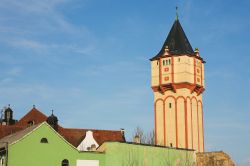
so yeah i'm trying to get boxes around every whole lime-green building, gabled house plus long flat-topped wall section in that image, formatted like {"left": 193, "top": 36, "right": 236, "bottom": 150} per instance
{"left": 0, "top": 122, "right": 195, "bottom": 166}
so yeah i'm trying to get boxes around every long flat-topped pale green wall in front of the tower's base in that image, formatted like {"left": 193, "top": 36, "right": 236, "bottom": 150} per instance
{"left": 103, "top": 142, "right": 195, "bottom": 166}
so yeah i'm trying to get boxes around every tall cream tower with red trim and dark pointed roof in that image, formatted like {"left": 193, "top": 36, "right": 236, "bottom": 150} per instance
{"left": 150, "top": 17, "right": 205, "bottom": 152}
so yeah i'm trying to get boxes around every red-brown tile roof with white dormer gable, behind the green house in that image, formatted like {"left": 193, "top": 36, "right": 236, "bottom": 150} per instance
{"left": 0, "top": 108, "right": 125, "bottom": 147}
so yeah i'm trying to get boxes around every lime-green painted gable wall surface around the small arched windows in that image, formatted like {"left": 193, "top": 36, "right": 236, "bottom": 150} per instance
{"left": 8, "top": 123, "right": 105, "bottom": 166}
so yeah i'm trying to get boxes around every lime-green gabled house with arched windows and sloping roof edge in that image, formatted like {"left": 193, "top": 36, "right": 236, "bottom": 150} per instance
{"left": 0, "top": 122, "right": 105, "bottom": 166}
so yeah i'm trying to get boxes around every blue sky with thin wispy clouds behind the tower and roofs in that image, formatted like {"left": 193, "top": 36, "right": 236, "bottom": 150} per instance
{"left": 0, "top": 0, "right": 250, "bottom": 166}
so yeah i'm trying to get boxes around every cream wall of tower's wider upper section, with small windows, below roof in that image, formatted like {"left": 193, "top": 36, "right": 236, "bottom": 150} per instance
{"left": 151, "top": 55, "right": 205, "bottom": 86}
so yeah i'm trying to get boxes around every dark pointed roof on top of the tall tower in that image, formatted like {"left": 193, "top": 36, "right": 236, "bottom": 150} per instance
{"left": 151, "top": 19, "right": 195, "bottom": 60}
